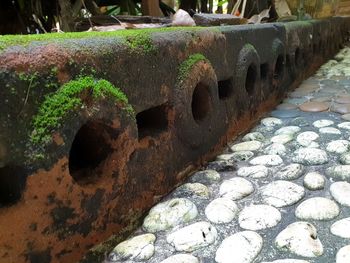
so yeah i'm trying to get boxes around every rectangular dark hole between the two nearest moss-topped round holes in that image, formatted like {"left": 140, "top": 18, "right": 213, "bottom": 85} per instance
{"left": 136, "top": 105, "right": 168, "bottom": 139}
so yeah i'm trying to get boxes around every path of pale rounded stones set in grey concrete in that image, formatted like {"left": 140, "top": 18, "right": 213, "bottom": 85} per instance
{"left": 105, "top": 48, "right": 350, "bottom": 263}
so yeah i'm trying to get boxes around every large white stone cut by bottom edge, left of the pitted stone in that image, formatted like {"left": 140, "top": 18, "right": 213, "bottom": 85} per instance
{"left": 215, "top": 231, "right": 263, "bottom": 263}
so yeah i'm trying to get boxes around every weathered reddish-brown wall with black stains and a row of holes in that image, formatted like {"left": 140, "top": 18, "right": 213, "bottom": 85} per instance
{"left": 0, "top": 18, "right": 350, "bottom": 263}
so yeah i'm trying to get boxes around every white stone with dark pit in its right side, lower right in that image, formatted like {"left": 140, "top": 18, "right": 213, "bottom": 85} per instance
{"left": 275, "top": 222, "right": 323, "bottom": 258}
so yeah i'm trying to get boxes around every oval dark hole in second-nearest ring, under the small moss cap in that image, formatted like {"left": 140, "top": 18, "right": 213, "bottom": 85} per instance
{"left": 192, "top": 82, "right": 211, "bottom": 122}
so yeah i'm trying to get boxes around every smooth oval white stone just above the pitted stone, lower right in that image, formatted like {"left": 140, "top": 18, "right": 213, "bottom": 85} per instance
{"left": 295, "top": 197, "right": 340, "bottom": 220}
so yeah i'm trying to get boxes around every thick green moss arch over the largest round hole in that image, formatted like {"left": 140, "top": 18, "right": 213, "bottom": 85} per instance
{"left": 30, "top": 76, "right": 134, "bottom": 144}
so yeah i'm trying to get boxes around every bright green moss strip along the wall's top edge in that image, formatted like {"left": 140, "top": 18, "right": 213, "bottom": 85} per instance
{"left": 0, "top": 27, "right": 207, "bottom": 52}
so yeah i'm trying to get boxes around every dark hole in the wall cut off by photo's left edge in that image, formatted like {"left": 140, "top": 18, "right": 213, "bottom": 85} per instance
{"left": 0, "top": 165, "right": 26, "bottom": 206}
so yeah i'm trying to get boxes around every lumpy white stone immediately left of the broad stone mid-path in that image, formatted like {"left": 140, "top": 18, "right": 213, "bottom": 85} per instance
{"left": 220, "top": 177, "right": 254, "bottom": 200}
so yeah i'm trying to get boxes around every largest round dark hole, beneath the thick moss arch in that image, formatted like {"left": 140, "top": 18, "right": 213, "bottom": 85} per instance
{"left": 69, "top": 121, "right": 112, "bottom": 183}
